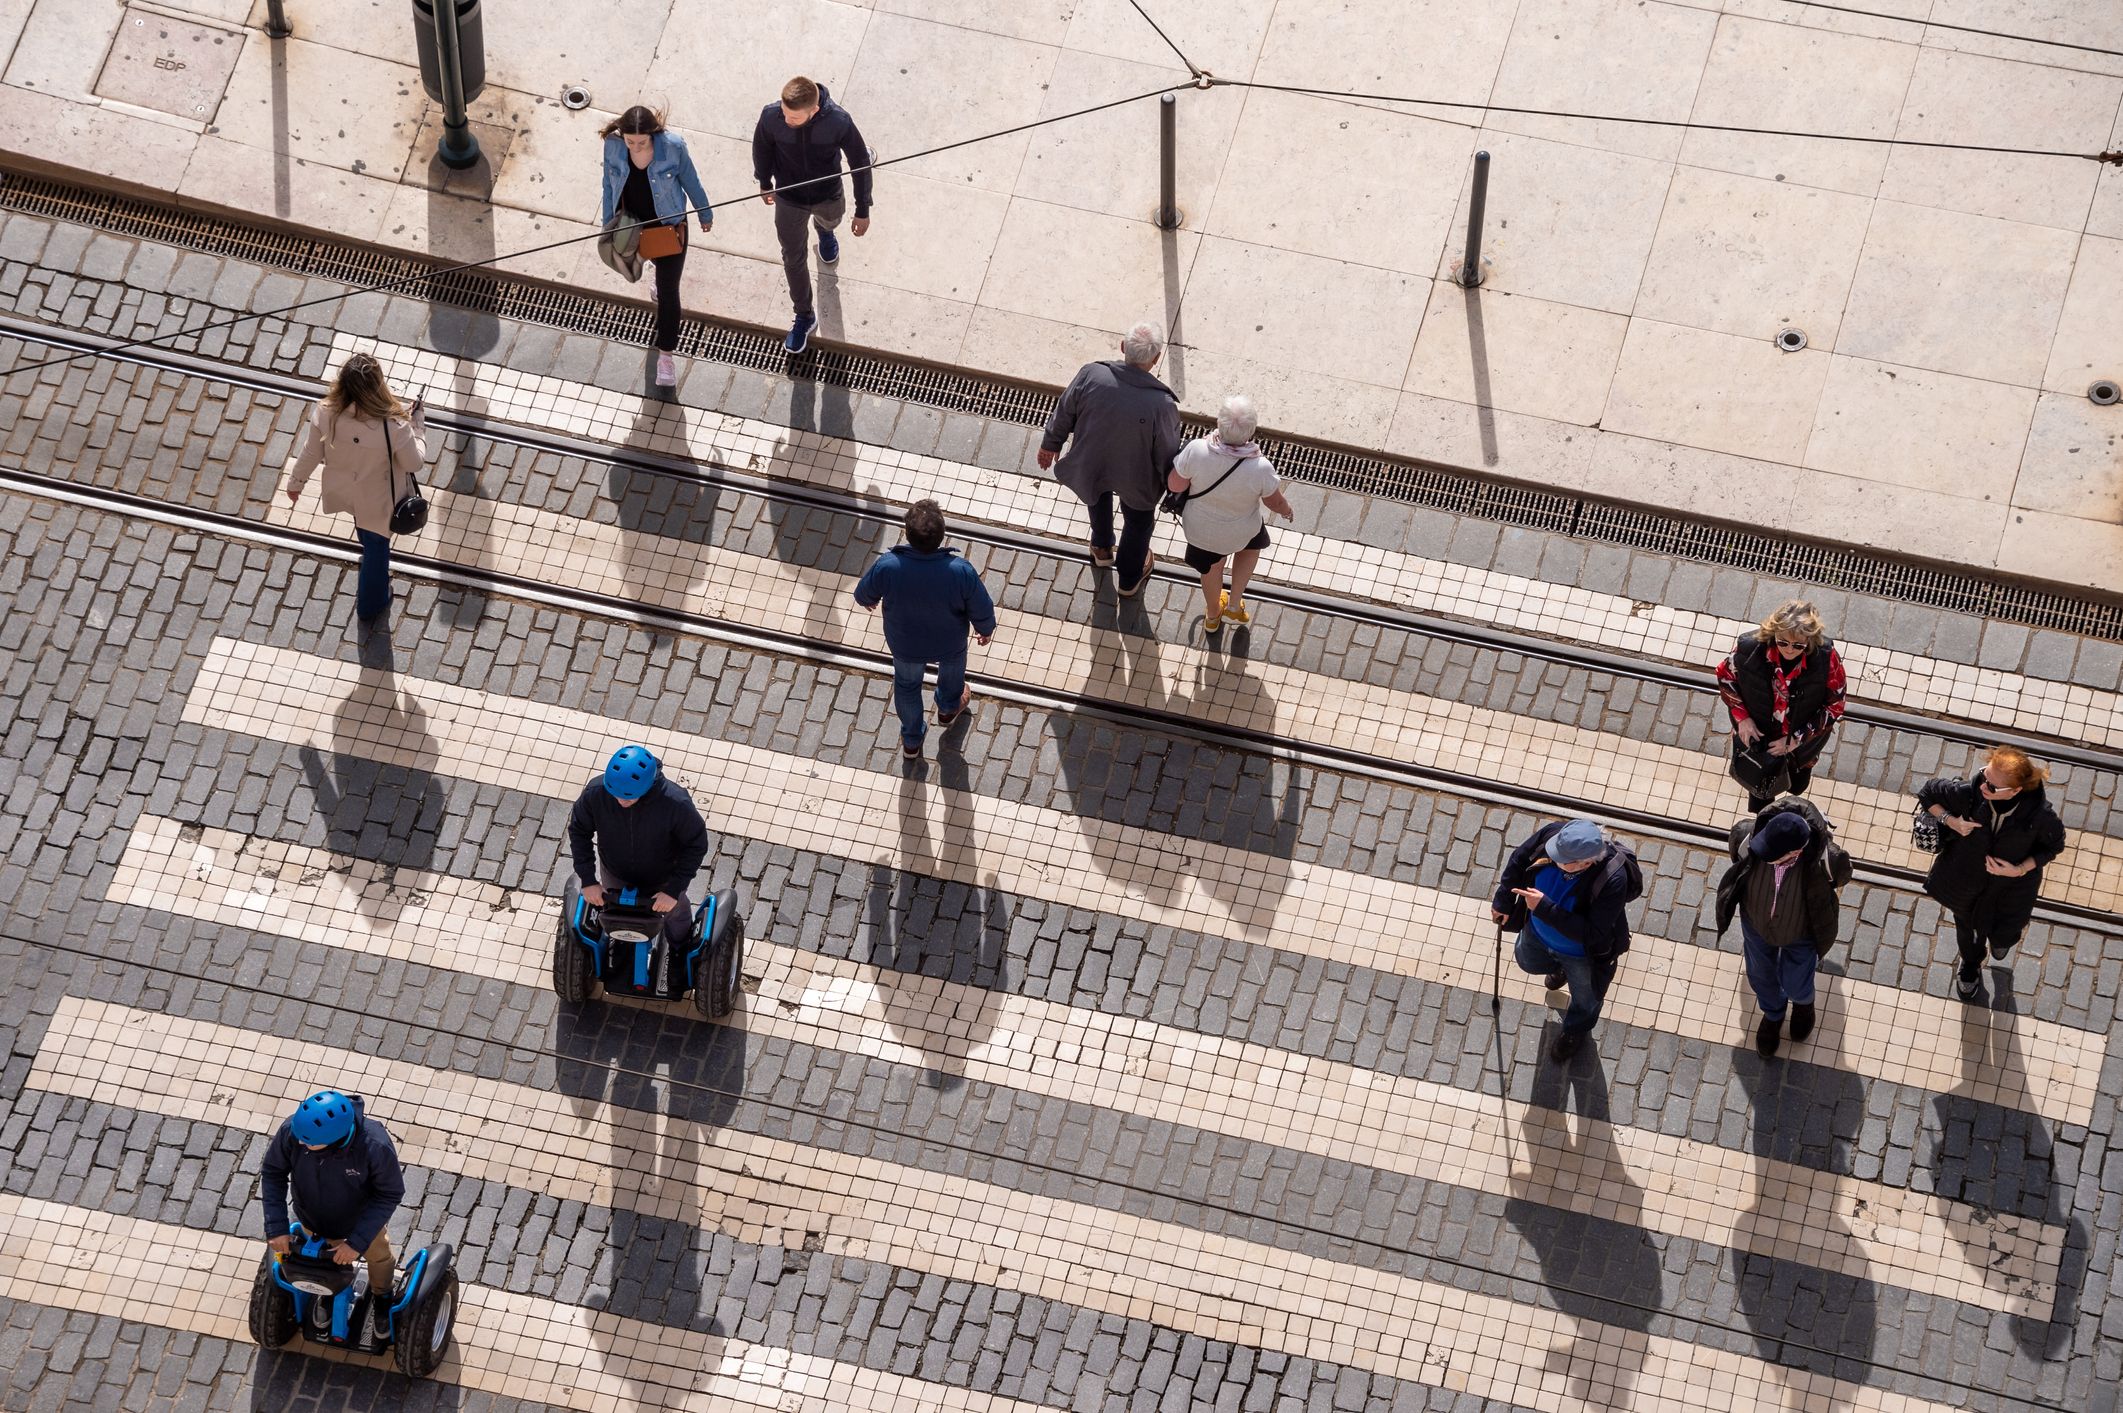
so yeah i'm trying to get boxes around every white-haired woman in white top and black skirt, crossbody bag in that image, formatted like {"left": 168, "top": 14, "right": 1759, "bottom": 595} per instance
{"left": 1166, "top": 397, "right": 1291, "bottom": 632}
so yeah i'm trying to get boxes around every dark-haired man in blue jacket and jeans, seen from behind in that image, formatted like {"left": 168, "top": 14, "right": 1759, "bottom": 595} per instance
{"left": 856, "top": 501, "right": 996, "bottom": 760}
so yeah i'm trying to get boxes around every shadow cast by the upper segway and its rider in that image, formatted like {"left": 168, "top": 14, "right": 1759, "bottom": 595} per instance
{"left": 552, "top": 988, "right": 749, "bottom": 1407}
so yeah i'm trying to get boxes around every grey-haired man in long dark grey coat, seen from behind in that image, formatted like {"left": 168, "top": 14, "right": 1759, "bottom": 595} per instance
{"left": 1040, "top": 322, "right": 1180, "bottom": 598}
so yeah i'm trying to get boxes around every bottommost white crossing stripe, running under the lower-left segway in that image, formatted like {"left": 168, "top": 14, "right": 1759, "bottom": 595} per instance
{"left": 0, "top": 1192, "right": 1053, "bottom": 1413}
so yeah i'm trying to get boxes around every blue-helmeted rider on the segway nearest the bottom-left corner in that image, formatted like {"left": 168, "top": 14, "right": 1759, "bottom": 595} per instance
{"left": 259, "top": 1088, "right": 405, "bottom": 1339}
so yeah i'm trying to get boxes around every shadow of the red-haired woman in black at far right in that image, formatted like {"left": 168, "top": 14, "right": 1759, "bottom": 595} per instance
{"left": 1926, "top": 965, "right": 2089, "bottom": 1360}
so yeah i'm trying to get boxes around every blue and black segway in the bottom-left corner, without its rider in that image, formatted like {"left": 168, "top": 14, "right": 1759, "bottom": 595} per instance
{"left": 251, "top": 1222, "right": 456, "bottom": 1379}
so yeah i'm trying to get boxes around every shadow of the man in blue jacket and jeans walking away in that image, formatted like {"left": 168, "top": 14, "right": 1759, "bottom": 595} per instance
{"left": 866, "top": 715, "right": 1013, "bottom": 1091}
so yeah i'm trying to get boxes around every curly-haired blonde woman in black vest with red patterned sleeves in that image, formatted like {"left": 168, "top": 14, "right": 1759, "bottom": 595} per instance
{"left": 1718, "top": 598, "right": 1843, "bottom": 815}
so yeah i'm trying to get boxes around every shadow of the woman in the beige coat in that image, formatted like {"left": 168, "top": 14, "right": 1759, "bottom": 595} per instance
{"left": 297, "top": 661, "right": 450, "bottom": 927}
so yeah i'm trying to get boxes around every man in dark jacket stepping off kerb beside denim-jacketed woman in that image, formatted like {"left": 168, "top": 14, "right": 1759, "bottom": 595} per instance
{"left": 752, "top": 74, "right": 870, "bottom": 354}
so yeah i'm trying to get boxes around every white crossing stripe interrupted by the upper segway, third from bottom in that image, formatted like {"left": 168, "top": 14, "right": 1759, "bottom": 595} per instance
{"left": 103, "top": 817, "right": 2064, "bottom": 1318}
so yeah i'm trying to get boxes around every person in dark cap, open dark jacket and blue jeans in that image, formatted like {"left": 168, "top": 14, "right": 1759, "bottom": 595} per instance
{"left": 1718, "top": 798, "right": 1851, "bottom": 1059}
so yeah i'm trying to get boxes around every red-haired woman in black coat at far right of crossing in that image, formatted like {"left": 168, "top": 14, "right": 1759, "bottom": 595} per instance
{"left": 1917, "top": 747, "right": 2064, "bottom": 1001}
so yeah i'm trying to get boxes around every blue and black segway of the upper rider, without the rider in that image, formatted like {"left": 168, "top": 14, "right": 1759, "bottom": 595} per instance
{"left": 552, "top": 878, "right": 745, "bottom": 1021}
